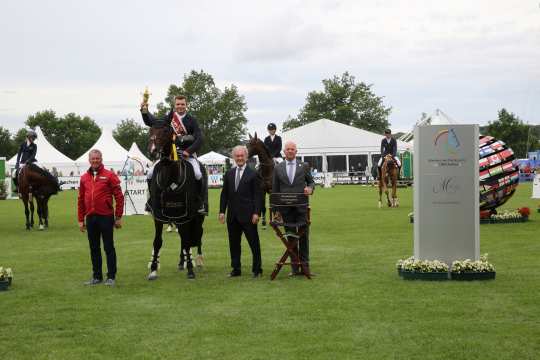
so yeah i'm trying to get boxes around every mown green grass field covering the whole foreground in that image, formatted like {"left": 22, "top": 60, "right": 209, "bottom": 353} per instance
{"left": 0, "top": 184, "right": 540, "bottom": 359}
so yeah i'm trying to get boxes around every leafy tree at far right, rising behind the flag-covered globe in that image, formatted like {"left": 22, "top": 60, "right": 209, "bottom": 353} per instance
{"left": 486, "top": 108, "right": 538, "bottom": 158}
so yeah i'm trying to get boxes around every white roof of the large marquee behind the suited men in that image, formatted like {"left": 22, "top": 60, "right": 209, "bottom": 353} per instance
{"left": 282, "top": 119, "right": 410, "bottom": 155}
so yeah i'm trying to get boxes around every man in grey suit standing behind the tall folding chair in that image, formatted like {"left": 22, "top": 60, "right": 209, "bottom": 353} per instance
{"left": 272, "top": 141, "right": 315, "bottom": 275}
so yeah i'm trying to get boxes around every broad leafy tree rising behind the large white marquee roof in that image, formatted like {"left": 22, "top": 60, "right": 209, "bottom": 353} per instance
{"left": 283, "top": 72, "right": 392, "bottom": 133}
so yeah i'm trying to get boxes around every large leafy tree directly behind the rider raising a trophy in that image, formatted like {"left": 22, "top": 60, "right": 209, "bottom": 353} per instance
{"left": 156, "top": 70, "right": 247, "bottom": 154}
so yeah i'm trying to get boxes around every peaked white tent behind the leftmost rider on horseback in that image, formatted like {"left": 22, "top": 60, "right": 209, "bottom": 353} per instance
{"left": 8, "top": 126, "right": 77, "bottom": 176}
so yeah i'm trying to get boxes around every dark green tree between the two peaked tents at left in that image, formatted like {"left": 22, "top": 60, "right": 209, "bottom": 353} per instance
{"left": 25, "top": 110, "right": 101, "bottom": 159}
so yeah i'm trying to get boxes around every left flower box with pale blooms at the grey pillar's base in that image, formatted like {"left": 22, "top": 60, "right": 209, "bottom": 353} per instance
{"left": 396, "top": 257, "right": 448, "bottom": 280}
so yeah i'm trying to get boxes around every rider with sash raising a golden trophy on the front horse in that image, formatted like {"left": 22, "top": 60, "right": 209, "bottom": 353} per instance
{"left": 141, "top": 95, "right": 208, "bottom": 214}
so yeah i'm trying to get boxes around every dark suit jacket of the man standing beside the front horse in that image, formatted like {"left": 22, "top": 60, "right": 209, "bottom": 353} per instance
{"left": 219, "top": 166, "right": 262, "bottom": 223}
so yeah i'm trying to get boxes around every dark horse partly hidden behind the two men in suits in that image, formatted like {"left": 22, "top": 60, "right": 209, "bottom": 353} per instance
{"left": 246, "top": 133, "right": 274, "bottom": 228}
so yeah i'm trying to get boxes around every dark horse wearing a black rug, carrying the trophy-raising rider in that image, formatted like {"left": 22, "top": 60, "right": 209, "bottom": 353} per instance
{"left": 148, "top": 122, "right": 204, "bottom": 280}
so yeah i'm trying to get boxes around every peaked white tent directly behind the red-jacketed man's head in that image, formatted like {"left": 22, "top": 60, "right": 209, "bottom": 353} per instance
{"left": 75, "top": 128, "right": 128, "bottom": 173}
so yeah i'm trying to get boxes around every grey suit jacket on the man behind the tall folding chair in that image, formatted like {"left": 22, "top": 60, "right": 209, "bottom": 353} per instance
{"left": 272, "top": 159, "right": 315, "bottom": 197}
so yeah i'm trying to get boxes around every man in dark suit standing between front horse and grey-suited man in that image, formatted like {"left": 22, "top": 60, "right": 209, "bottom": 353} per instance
{"left": 219, "top": 146, "right": 262, "bottom": 278}
